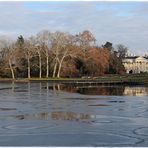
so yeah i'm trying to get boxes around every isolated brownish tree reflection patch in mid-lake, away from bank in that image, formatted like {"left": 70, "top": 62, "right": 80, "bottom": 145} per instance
{"left": 51, "top": 111, "right": 91, "bottom": 121}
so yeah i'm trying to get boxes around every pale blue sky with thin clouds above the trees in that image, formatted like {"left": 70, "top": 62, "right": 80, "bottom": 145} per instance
{"left": 0, "top": 1, "right": 148, "bottom": 55}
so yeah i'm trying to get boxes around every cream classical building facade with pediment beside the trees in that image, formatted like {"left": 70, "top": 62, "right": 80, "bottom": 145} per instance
{"left": 122, "top": 56, "right": 148, "bottom": 73}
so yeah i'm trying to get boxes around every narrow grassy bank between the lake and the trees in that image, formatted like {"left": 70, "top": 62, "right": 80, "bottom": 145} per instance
{"left": 0, "top": 74, "right": 148, "bottom": 84}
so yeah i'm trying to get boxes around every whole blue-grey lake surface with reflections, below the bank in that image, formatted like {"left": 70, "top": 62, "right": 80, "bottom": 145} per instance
{"left": 0, "top": 83, "right": 148, "bottom": 146}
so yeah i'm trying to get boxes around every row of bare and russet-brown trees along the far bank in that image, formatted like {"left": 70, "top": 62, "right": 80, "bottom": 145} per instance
{"left": 0, "top": 30, "right": 128, "bottom": 79}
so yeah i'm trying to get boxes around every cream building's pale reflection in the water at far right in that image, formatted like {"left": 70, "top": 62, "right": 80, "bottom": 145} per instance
{"left": 124, "top": 87, "right": 148, "bottom": 96}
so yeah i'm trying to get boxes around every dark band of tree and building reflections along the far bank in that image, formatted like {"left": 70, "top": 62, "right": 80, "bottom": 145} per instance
{"left": 42, "top": 84, "right": 148, "bottom": 96}
